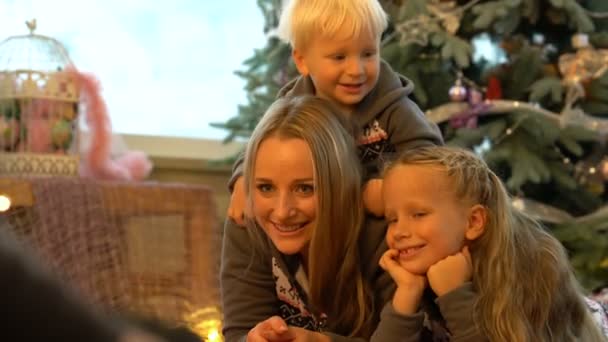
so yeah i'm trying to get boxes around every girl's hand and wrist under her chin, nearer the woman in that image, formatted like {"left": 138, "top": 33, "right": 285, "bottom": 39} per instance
{"left": 380, "top": 249, "right": 427, "bottom": 315}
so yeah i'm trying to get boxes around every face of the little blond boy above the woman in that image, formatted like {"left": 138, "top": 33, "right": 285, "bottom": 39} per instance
{"left": 293, "top": 26, "right": 380, "bottom": 113}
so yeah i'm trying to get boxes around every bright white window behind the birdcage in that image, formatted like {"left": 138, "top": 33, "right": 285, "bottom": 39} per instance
{"left": 0, "top": 0, "right": 266, "bottom": 139}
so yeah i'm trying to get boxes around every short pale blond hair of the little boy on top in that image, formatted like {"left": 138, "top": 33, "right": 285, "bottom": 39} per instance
{"left": 278, "top": 0, "right": 388, "bottom": 49}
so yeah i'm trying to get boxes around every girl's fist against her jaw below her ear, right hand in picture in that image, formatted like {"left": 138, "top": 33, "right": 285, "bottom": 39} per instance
{"left": 426, "top": 246, "right": 473, "bottom": 296}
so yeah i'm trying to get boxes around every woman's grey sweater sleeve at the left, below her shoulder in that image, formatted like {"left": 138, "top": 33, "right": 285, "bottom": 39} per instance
{"left": 220, "top": 220, "right": 277, "bottom": 342}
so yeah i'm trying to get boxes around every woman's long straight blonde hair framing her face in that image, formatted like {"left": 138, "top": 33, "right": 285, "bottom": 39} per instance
{"left": 244, "top": 96, "right": 371, "bottom": 335}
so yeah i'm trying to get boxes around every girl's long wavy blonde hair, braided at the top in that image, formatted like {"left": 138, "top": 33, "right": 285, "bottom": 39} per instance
{"left": 385, "top": 146, "right": 605, "bottom": 342}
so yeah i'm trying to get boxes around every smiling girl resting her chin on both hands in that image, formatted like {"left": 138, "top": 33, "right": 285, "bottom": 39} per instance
{"left": 377, "top": 147, "right": 608, "bottom": 341}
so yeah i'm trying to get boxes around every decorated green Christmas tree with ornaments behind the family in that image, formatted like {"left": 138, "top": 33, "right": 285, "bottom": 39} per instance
{"left": 214, "top": 0, "right": 608, "bottom": 289}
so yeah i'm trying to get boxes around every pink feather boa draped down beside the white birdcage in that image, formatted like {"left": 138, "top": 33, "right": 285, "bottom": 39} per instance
{"left": 66, "top": 68, "right": 152, "bottom": 181}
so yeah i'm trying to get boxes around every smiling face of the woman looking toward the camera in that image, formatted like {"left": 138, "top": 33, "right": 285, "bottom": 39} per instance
{"left": 253, "top": 136, "right": 317, "bottom": 255}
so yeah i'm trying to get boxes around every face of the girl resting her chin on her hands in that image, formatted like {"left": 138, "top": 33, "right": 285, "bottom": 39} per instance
{"left": 383, "top": 165, "right": 480, "bottom": 275}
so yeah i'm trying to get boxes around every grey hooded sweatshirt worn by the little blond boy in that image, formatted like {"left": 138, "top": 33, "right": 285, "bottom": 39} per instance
{"left": 228, "top": 61, "right": 443, "bottom": 191}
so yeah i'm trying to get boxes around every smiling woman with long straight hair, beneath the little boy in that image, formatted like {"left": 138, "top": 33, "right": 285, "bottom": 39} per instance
{"left": 221, "top": 96, "right": 394, "bottom": 342}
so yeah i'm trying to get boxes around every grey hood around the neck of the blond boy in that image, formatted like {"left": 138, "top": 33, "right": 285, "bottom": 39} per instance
{"left": 277, "top": 60, "right": 414, "bottom": 127}
